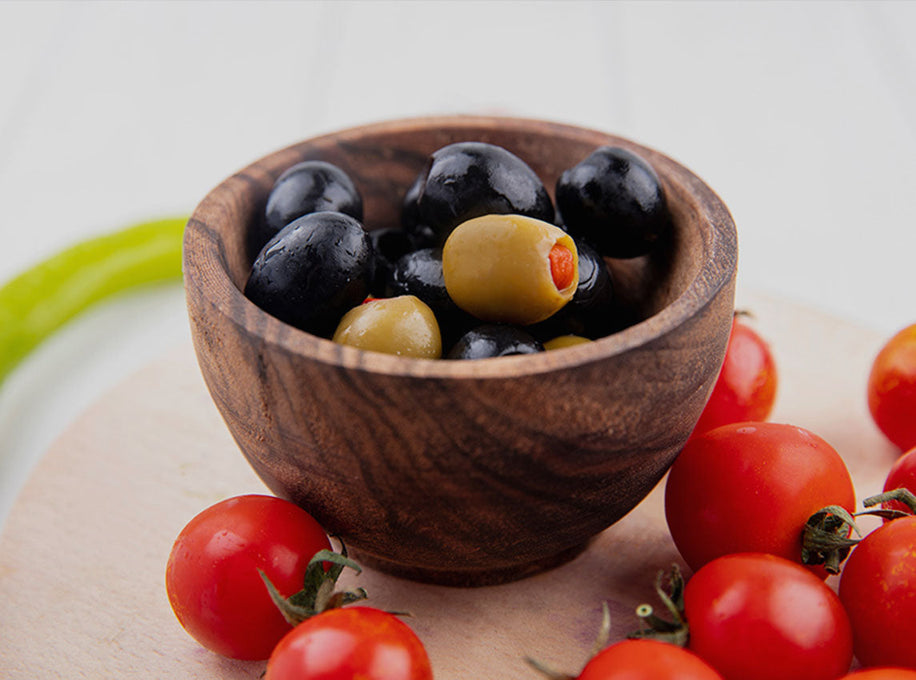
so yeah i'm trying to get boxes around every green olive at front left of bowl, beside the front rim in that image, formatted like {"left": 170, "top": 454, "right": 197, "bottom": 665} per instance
{"left": 332, "top": 295, "right": 442, "bottom": 359}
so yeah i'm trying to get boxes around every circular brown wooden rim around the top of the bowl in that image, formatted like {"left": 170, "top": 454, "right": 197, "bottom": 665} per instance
{"left": 182, "top": 115, "right": 738, "bottom": 380}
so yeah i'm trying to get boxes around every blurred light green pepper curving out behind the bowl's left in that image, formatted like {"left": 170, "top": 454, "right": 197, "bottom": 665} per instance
{"left": 0, "top": 218, "right": 187, "bottom": 383}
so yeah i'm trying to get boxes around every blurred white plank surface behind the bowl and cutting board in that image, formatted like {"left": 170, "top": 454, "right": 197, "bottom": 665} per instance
{"left": 0, "top": 1, "right": 916, "bottom": 521}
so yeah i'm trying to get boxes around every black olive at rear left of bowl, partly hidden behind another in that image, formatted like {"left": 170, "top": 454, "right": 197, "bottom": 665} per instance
{"left": 250, "top": 161, "right": 363, "bottom": 252}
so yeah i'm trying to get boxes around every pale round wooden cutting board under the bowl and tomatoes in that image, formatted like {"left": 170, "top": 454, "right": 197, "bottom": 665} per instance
{"left": 0, "top": 295, "right": 898, "bottom": 680}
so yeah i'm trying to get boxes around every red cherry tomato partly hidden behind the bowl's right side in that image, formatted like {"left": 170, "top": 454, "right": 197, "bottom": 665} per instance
{"left": 693, "top": 318, "right": 777, "bottom": 435}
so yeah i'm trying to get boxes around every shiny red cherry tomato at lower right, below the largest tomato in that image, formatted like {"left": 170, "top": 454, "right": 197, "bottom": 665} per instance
{"left": 684, "top": 553, "right": 852, "bottom": 680}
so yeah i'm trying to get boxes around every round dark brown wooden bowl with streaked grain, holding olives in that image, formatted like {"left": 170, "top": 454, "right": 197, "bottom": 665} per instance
{"left": 184, "top": 117, "right": 737, "bottom": 585}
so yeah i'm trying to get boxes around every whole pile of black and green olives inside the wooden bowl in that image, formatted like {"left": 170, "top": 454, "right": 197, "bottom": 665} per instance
{"left": 245, "top": 142, "right": 671, "bottom": 359}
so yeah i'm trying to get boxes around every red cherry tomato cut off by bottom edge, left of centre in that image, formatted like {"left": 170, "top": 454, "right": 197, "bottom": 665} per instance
{"left": 264, "top": 607, "right": 433, "bottom": 680}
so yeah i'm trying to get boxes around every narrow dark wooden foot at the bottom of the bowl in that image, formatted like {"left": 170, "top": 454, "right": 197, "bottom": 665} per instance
{"left": 348, "top": 541, "right": 591, "bottom": 588}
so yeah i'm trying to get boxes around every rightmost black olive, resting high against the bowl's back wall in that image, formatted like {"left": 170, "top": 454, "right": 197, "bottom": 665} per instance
{"left": 556, "top": 146, "right": 671, "bottom": 258}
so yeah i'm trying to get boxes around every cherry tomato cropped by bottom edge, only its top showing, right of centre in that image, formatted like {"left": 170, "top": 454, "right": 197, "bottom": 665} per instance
{"left": 577, "top": 640, "right": 722, "bottom": 680}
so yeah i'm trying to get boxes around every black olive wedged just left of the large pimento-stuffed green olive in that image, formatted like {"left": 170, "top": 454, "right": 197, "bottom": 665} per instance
{"left": 386, "top": 248, "right": 480, "bottom": 343}
